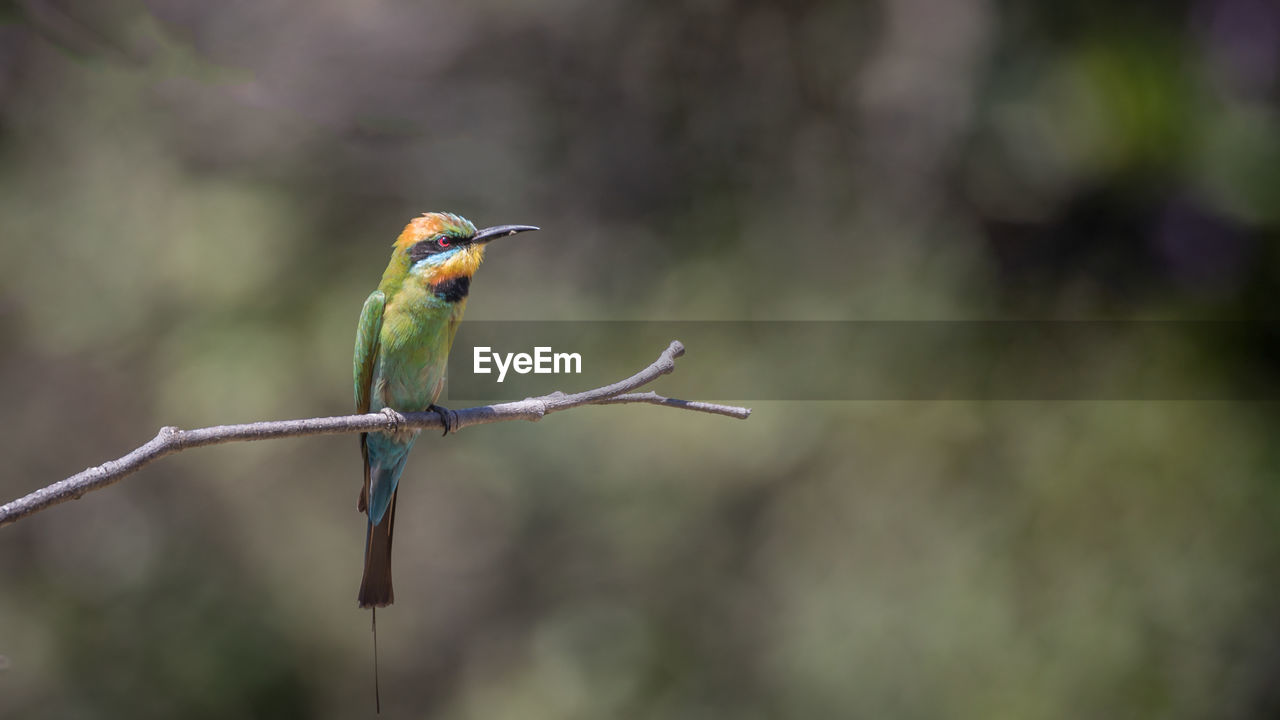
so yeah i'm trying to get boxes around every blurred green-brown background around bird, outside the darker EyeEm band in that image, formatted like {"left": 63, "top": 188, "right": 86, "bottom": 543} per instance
{"left": 0, "top": 0, "right": 1280, "bottom": 720}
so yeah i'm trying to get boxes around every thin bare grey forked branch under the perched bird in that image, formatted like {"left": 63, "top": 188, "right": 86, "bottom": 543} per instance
{"left": 0, "top": 341, "right": 751, "bottom": 527}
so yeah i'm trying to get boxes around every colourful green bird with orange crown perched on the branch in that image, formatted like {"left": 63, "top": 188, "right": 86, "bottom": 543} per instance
{"left": 355, "top": 213, "right": 538, "bottom": 607}
